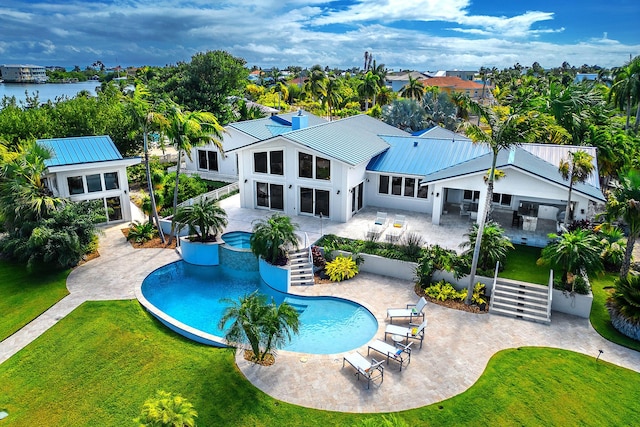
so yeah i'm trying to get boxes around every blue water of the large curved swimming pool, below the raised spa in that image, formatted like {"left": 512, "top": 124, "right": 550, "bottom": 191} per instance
{"left": 141, "top": 261, "right": 378, "bottom": 354}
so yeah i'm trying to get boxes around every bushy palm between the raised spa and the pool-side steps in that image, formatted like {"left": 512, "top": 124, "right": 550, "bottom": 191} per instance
{"left": 250, "top": 213, "right": 298, "bottom": 265}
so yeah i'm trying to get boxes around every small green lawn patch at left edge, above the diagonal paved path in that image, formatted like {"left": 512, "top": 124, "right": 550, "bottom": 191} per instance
{"left": 0, "top": 260, "right": 70, "bottom": 341}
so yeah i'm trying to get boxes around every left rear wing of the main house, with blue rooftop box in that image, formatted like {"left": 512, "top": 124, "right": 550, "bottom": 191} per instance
{"left": 183, "top": 111, "right": 326, "bottom": 182}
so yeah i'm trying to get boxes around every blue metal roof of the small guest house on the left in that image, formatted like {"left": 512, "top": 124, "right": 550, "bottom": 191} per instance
{"left": 37, "top": 135, "right": 123, "bottom": 167}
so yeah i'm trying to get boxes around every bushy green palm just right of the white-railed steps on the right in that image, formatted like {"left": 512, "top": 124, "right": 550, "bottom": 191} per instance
{"left": 538, "top": 228, "right": 604, "bottom": 291}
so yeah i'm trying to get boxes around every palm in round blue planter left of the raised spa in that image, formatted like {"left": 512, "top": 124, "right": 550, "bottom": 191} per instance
{"left": 175, "top": 198, "right": 227, "bottom": 265}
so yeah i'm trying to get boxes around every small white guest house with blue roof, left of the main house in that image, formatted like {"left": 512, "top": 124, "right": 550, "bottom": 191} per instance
{"left": 37, "top": 135, "right": 141, "bottom": 223}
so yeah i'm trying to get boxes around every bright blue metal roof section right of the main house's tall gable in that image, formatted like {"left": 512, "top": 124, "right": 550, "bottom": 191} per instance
{"left": 367, "top": 136, "right": 489, "bottom": 176}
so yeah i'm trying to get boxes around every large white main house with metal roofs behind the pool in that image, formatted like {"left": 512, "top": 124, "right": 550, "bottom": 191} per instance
{"left": 186, "top": 115, "right": 605, "bottom": 241}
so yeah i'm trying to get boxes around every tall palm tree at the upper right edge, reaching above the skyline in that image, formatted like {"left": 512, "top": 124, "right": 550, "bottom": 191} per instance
{"left": 609, "top": 56, "right": 640, "bottom": 130}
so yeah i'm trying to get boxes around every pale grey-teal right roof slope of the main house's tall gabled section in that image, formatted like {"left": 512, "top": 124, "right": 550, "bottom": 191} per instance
{"left": 283, "top": 114, "right": 410, "bottom": 165}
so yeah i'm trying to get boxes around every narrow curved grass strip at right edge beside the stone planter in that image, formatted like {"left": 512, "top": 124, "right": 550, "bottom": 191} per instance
{"left": 589, "top": 273, "right": 640, "bottom": 351}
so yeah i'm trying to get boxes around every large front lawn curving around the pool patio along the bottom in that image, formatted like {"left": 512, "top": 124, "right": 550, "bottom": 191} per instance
{"left": 0, "top": 301, "right": 640, "bottom": 426}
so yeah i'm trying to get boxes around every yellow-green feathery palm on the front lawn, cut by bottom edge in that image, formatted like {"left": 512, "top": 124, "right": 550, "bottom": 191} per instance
{"left": 134, "top": 390, "right": 198, "bottom": 427}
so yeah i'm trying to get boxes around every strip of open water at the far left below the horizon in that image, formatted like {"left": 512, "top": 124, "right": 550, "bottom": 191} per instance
{"left": 0, "top": 80, "right": 100, "bottom": 104}
